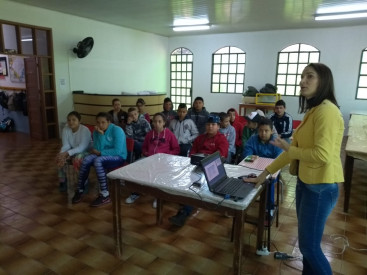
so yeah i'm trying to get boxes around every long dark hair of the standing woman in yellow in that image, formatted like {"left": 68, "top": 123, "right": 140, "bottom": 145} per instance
{"left": 299, "top": 63, "right": 339, "bottom": 113}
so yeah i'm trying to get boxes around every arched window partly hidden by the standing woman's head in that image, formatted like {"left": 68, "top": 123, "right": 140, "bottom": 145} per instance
{"left": 275, "top": 43, "right": 320, "bottom": 96}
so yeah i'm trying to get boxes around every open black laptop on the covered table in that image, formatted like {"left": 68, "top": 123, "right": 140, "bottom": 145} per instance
{"left": 201, "top": 151, "right": 255, "bottom": 199}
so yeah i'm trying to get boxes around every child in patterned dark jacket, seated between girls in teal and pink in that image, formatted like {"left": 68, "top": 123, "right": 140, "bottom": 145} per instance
{"left": 126, "top": 107, "right": 152, "bottom": 160}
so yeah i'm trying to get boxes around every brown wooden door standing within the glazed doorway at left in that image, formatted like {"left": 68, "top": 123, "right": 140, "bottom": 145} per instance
{"left": 24, "top": 57, "right": 46, "bottom": 140}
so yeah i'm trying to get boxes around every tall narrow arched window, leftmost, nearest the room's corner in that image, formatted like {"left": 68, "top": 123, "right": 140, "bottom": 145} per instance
{"left": 170, "top": 48, "right": 193, "bottom": 110}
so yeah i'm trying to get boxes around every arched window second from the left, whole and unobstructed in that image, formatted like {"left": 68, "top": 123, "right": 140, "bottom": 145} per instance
{"left": 211, "top": 46, "right": 246, "bottom": 94}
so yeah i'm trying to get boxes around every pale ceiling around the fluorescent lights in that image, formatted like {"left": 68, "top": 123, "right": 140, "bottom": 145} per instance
{"left": 11, "top": 0, "right": 367, "bottom": 37}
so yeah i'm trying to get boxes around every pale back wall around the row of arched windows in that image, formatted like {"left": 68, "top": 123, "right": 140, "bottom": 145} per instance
{"left": 169, "top": 26, "right": 367, "bottom": 126}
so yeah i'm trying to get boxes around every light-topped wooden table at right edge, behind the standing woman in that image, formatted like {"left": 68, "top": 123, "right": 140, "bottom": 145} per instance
{"left": 344, "top": 114, "right": 367, "bottom": 212}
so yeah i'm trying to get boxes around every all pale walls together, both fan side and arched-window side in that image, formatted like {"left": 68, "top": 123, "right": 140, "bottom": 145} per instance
{"left": 0, "top": 0, "right": 367, "bottom": 133}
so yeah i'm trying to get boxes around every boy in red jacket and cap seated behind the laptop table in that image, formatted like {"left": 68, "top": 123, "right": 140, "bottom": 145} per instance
{"left": 169, "top": 115, "right": 229, "bottom": 226}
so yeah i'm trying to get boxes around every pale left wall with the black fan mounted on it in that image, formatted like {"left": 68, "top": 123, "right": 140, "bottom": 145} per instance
{"left": 0, "top": 0, "right": 169, "bottom": 127}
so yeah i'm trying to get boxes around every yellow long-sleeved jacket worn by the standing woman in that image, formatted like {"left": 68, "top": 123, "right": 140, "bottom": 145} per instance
{"left": 266, "top": 100, "right": 344, "bottom": 184}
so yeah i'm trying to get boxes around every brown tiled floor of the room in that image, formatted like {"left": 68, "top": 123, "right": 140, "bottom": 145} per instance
{"left": 0, "top": 133, "right": 367, "bottom": 275}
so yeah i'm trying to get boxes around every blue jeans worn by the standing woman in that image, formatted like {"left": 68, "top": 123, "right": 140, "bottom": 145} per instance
{"left": 296, "top": 179, "right": 339, "bottom": 275}
